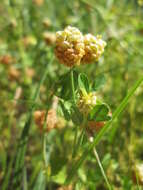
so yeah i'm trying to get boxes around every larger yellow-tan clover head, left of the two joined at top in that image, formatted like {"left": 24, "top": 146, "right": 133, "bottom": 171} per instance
{"left": 55, "top": 26, "right": 85, "bottom": 67}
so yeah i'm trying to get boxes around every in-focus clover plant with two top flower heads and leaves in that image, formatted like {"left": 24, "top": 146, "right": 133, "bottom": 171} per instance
{"left": 55, "top": 26, "right": 110, "bottom": 135}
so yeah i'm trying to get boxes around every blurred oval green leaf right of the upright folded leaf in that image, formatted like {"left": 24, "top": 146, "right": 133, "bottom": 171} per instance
{"left": 92, "top": 74, "right": 106, "bottom": 91}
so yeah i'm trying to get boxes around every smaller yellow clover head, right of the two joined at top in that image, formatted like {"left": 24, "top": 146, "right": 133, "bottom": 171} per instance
{"left": 82, "top": 34, "right": 106, "bottom": 64}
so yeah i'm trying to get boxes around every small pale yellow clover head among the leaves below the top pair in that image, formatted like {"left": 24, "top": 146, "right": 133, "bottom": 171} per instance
{"left": 77, "top": 92, "right": 97, "bottom": 115}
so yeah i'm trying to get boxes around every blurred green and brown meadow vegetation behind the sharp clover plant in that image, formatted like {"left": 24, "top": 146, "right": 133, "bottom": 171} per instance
{"left": 0, "top": 0, "right": 143, "bottom": 190}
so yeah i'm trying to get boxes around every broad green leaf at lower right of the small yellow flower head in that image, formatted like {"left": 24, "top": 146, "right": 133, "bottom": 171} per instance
{"left": 89, "top": 103, "right": 111, "bottom": 121}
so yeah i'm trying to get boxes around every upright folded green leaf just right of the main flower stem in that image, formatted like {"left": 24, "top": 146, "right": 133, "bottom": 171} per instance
{"left": 78, "top": 73, "right": 89, "bottom": 92}
